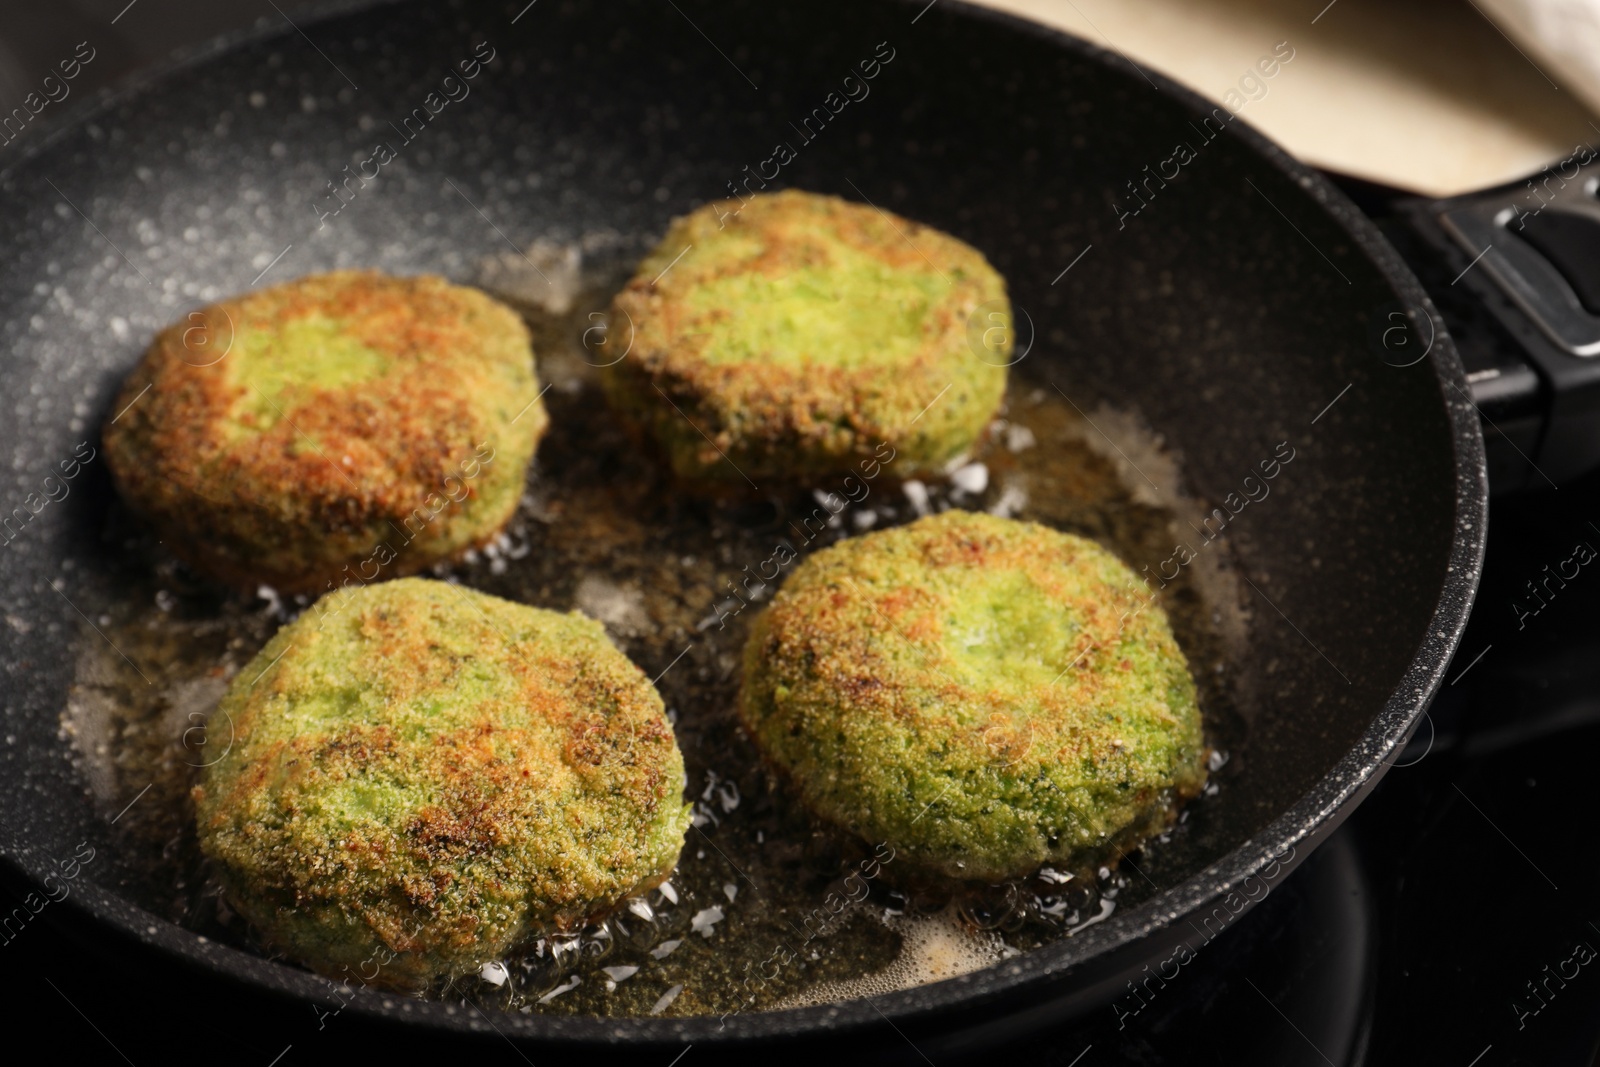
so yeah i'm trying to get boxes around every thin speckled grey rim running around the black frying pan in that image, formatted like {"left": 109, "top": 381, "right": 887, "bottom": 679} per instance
{"left": 0, "top": 0, "right": 1488, "bottom": 1048}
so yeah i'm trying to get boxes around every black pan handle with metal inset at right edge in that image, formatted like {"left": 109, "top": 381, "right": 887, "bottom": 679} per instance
{"left": 1379, "top": 159, "right": 1600, "bottom": 496}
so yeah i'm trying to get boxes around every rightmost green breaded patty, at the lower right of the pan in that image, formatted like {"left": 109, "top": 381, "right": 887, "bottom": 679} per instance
{"left": 739, "top": 510, "right": 1206, "bottom": 880}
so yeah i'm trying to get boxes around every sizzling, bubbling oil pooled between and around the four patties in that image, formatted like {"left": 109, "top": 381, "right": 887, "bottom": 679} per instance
{"left": 62, "top": 247, "right": 1242, "bottom": 1016}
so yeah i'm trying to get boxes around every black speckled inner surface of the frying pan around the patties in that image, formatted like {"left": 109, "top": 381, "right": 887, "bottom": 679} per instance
{"left": 0, "top": 3, "right": 1456, "bottom": 1036}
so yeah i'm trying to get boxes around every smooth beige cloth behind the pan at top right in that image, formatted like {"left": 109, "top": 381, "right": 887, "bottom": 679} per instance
{"left": 978, "top": 0, "right": 1600, "bottom": 195}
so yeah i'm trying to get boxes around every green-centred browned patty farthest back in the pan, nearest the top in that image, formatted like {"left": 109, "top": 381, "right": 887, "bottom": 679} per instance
{"left": 605, "top": 190, "right": 1010, "bottom": 482}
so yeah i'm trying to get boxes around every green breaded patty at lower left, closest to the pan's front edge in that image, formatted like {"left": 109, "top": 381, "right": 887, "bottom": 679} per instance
{"left": 194, "top": 579, "right": 690, "bottom": 987}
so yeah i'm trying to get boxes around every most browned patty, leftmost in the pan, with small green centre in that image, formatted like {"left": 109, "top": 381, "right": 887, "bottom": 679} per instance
{"left": 104, "top": 272, "right": 547, "bottom": 590}
